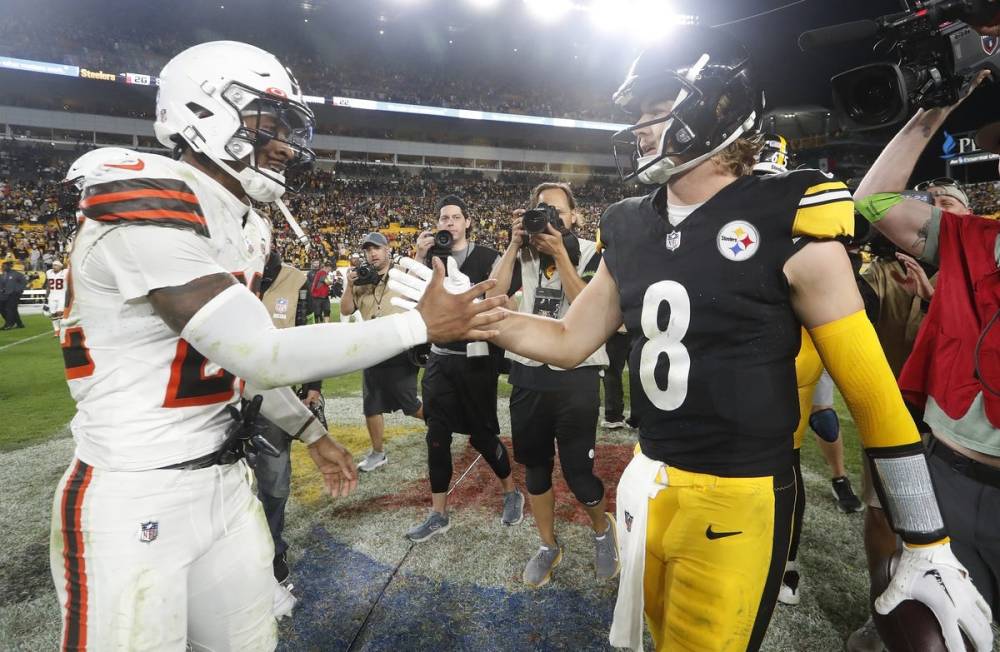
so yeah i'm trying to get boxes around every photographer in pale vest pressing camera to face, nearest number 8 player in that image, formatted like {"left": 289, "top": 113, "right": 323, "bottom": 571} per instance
{"left": 488, "top": 183, "right": 618, "bottom": 588}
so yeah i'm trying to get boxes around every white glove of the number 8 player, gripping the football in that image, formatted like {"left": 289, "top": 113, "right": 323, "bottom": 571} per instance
{"left": 875, "top": 543, "right": 993, "bottom": 652}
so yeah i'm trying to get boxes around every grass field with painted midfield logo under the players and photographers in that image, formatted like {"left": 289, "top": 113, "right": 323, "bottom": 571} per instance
{"left": 0, "top": 306, "right": 908, "bottom": 651}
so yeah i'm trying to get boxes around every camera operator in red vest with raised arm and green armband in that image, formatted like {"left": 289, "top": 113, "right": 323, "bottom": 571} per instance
{"left": 855, "top": 74, "right": 1000, "bottom": 632}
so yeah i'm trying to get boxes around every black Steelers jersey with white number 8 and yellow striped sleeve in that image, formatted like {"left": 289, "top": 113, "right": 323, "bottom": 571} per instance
{"left": 600, "top": 170, "right": 854, "bottom": 476}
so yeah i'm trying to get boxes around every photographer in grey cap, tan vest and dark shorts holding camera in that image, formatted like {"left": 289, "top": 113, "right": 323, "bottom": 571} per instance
{"left": 340, "top": 231, "right": 424, "bottom": 471}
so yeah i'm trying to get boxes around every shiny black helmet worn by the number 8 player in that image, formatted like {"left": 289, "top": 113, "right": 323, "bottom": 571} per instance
{"left": 612, "top": 26, "right": 764, "bottom": 185}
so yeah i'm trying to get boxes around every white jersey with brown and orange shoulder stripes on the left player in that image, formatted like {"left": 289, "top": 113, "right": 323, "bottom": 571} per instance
{"left": 62, "top": 153, "right": 271, "bottom": 471}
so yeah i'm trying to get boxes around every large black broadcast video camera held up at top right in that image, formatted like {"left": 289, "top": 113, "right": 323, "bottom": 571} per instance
{"left": 799, "top": 0, "right": 1000, "bottom": 130}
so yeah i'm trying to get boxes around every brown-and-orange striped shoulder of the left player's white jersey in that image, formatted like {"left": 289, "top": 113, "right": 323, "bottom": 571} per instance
{"left": 79, "top": 152, "right": 209, "bottom": 237}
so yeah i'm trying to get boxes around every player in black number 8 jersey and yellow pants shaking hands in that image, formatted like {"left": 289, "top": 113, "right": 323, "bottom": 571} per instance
{"left": 486, "top": 27, "right": 992, "bottom": 651}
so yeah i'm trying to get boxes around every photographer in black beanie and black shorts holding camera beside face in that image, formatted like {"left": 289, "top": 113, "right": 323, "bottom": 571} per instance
{"left": 406, "top": 195, "right": 524, "bottom": 541}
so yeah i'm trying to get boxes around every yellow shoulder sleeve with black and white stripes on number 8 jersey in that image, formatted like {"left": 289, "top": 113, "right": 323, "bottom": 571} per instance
{"left": 781, "top": 169, "right": 854, "bottom": 238}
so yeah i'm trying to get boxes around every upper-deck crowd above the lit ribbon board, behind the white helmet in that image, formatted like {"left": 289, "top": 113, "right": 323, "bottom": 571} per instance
{"left": 0, "top": 7, "right": 614, "bottom": 120}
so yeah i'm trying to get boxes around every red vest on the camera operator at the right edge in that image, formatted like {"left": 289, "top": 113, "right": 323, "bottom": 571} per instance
{"left": 899, "top": 213, "right": 1000, "bottom": 428}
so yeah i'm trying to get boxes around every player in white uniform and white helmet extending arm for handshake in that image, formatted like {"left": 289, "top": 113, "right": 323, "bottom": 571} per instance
{"left": 51, "top": 41, "right": 503, "bottom": 650}
